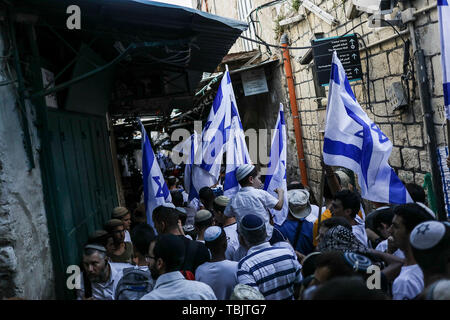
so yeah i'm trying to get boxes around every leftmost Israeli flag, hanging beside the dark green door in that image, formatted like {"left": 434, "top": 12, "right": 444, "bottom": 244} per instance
{"left": 139, "top": 121, "right": 172, "bottom": 228}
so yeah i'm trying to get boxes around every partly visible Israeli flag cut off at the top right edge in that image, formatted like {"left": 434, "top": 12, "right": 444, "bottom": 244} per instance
{"left": 437, "top": 0, "right": 450, "bottom": 120}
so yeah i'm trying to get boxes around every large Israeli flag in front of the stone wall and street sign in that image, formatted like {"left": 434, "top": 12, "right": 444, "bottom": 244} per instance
{"left": 323, "top": 51, "right": 413, "bottom": 204}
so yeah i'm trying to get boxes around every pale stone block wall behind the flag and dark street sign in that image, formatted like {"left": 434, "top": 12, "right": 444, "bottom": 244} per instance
{"left": 210, "top": 0, "right": 447, "bottom": 200}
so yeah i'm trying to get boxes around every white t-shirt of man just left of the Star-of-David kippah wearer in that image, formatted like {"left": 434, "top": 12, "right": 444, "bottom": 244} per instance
{"left": 392, "top": 264, "right": 424, "bottom": 300}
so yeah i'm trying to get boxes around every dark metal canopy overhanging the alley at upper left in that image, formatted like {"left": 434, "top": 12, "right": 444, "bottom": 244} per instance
{"left": 14, "top": 0, "right": 248, "bottom": 114}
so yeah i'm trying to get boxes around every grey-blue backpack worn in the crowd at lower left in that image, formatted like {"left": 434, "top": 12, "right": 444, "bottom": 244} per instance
{"left": 114, "top": 267, "right": 153, "bottom": 300}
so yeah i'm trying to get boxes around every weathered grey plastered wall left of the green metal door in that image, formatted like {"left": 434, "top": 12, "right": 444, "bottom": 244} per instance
{"left": 0, "top": 28, "right": 54, "bottom": 299}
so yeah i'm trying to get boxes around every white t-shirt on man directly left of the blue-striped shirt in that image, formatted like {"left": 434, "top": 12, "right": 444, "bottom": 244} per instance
{"left": 195, "top": 260, "right": 238, "bottom": 300}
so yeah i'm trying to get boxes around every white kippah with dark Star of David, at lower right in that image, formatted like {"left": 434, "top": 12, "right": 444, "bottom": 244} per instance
{"left": 409, "top": 221, "right": 445, "bottom": 250}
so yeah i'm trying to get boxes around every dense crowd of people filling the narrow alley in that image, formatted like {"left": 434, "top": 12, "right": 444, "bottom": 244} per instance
{"left": 77, "top": 164, "right": 450, "bottom": 300}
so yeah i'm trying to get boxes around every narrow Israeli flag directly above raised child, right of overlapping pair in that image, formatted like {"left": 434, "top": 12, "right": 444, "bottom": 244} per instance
{"left": 223, "top": 97, "right": 251, "bottom": 198}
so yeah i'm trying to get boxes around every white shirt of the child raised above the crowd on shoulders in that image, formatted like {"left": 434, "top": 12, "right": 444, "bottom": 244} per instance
{"left": 224, "top": 187, "right": 278, "bottom": 240}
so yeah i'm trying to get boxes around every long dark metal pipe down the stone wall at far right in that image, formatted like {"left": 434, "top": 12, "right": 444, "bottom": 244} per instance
{"left": 408, "top": 4, "right": 447, "bottom": 221}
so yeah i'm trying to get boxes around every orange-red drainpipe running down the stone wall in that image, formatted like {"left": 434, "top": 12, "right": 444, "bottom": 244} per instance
{"left": 281, "top": 34, "right": 308, "bottom": 186}
